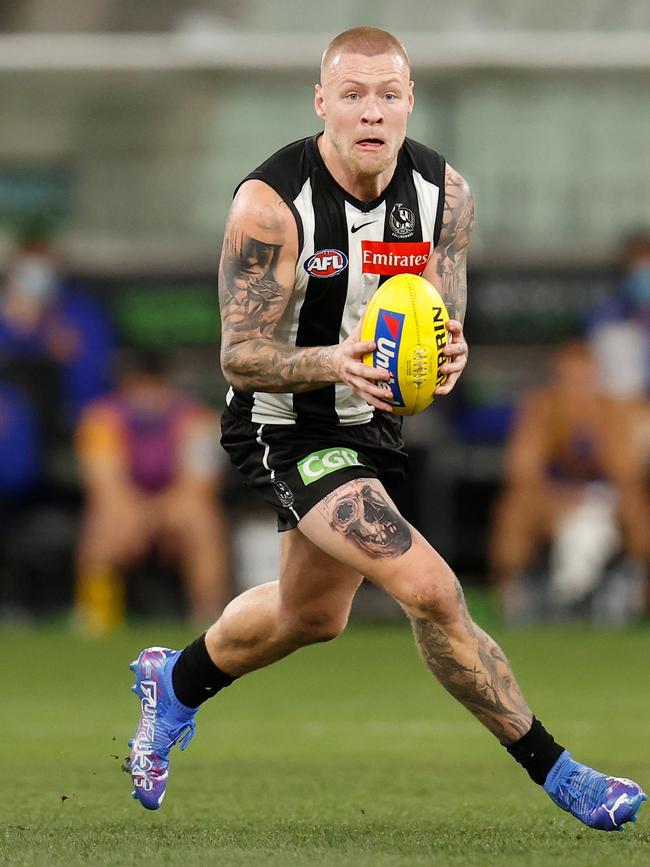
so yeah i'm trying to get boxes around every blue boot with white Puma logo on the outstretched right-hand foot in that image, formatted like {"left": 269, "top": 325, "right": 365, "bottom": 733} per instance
{"left": 544, "top": 750, "right": 648, "bottom": 831}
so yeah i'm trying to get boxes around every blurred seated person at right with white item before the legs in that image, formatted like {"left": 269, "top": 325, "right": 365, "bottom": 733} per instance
{"left": 489, "top": 341, "right": 650, "bottom": 619}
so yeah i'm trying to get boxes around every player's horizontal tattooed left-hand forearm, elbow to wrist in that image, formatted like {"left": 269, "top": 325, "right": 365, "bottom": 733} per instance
{"left": 221, "top": 339, "right": 338, "bottom": 393}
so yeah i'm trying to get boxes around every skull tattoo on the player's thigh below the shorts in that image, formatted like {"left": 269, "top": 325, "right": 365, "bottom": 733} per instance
{"left": 321, "top": 482, "right": 412, "bottom": 560}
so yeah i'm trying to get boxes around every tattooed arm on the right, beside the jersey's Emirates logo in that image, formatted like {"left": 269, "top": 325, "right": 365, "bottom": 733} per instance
{"left": 435, "top": 166, "right": 474, "bottom": 322}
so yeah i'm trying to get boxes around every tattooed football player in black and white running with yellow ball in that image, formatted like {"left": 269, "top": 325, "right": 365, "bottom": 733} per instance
{"left": 125, "top": 27, "right": 646, "bottom": 831}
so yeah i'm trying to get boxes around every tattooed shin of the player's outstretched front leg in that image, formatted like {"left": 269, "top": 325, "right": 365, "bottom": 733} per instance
{"left": 411, "top": 583, "right": 532, "bottom": 743}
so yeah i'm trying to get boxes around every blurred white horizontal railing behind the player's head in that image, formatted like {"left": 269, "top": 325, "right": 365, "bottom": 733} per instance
{"left": 0, "top": 31, "right": 650, "bottom": 73}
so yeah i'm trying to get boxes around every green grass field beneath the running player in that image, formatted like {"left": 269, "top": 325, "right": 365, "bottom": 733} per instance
{"left": 0, "top": 624, "right": 650, "bottom": 867}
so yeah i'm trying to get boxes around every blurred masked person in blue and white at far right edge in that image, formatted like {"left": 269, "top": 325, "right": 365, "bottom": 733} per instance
{"left": 587, "top": 234, "right": 650, "bottom": 399}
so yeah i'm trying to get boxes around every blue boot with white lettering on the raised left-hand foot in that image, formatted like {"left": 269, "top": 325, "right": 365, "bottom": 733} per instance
{"left": 128, "top": 647, "right": 198, "bottom": 810}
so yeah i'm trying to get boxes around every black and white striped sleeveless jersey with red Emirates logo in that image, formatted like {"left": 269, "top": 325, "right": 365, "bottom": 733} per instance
{"left": 228, "top": 136, "right": 445, "bottom": 425}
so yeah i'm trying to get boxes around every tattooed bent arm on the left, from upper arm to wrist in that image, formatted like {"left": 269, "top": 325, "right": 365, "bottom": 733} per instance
{"left": 219, "top": 208, "right": 336, "bottom": 392}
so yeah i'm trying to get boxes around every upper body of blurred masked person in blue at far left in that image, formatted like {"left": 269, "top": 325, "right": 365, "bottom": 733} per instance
{"left": 0, "top": 227, "right": 114, "bottom": 434}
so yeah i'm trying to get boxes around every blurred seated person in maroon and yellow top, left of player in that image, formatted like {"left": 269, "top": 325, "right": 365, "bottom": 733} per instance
{"left": 76, "top": 351, "right": 229, "bottom": 634}
